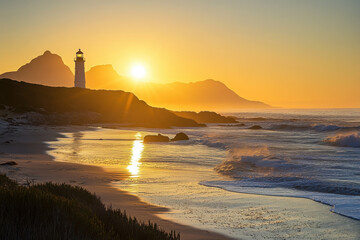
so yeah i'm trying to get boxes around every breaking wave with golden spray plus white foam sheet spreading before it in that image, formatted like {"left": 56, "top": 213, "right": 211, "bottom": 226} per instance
{"left": 208, "top": 145, "right": 360, "bottom": 219}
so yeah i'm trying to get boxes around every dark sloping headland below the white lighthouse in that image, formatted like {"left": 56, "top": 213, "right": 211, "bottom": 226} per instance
{"left": 0, "top": 79, "right": 204, "bottom": 128}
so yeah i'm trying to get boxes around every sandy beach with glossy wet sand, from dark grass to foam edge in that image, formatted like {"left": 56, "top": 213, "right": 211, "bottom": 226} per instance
{"left": 0, "top": 123, "right": 360, "bottom": 240}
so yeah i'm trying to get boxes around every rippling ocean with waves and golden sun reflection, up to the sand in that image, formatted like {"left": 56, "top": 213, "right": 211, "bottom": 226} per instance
{"left": 48, "top": 109, "right": 360, "bottom": 239}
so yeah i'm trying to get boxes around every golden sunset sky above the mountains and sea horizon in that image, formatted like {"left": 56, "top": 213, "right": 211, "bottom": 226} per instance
{"left": 0, "top": 0, "right": 360, "bottom": 108}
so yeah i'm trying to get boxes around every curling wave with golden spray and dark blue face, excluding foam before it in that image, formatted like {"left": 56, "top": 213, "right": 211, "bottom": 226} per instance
{"left": 215, "top": 146, "right": 360, "bottom": 196}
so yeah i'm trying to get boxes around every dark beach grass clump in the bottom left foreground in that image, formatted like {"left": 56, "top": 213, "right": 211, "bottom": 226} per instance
{"left": 0, "top": 174, "right": 180, "bottom": 240}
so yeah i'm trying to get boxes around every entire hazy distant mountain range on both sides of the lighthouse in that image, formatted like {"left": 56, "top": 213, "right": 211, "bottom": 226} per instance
{"left": 0, "top": 51, "right": 270, "bottom": 111}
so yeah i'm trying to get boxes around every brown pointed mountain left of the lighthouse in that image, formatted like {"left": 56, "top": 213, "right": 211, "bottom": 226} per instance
{"left": 0, "top": 51, "right": 74, "bottom": 87}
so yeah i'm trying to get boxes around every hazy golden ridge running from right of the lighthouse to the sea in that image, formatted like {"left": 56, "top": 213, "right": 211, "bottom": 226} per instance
{"left": 86, "top": 65, "right": 270, "bottom": 111}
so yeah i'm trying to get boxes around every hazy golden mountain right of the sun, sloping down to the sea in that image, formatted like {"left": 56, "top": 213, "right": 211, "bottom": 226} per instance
{"left": 133, "top": 79, "right": 269, "bottom": 111}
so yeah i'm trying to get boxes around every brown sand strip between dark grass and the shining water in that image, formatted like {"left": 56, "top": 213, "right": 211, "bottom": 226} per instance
{"left": 0, "top": 125, "right": 232, "bottom": 240}
